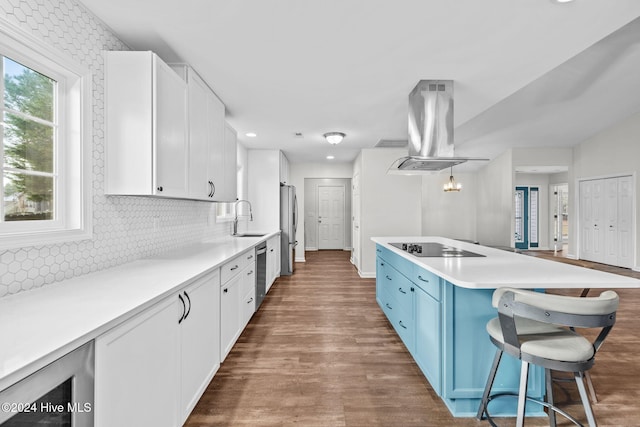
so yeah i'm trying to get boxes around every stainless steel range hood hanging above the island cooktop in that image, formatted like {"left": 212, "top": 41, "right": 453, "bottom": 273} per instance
{"left": 388, "top": 80, "right": 488, "bottom": 174}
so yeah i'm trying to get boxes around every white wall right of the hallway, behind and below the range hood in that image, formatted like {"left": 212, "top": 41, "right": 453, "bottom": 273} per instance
{"left": 354, "top": 148, "right": 422, "bottom": 277}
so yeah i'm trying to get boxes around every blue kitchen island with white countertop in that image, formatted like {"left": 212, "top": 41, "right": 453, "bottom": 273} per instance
{"left": 372, "top": 237, "right": 640, "bottom": 417}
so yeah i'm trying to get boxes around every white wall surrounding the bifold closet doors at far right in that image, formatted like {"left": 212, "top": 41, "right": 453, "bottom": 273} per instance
{"left": 569, "top": 113, "right": 640, "bottom": 270}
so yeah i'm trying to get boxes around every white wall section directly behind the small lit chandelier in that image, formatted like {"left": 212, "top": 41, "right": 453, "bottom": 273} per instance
{"left": 422, "top": 173, "right": 478, "bottom": 240}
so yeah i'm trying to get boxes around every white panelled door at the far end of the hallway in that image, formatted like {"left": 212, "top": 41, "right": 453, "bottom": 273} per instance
{"left": 318, "top": 185, "right": 344, "bottom": 249}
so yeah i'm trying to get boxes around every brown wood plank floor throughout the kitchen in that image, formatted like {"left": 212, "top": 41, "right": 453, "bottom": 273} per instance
{"left": 185, "top": 251, "right": 640, "bottom": 427}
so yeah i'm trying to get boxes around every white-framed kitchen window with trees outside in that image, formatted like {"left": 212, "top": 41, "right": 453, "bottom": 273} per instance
{"left": 0, "top": 23, "right": 91, "bottom": 249}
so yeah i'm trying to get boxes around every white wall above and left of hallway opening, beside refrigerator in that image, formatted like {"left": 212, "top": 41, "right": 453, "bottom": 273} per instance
{"left": 289, "top": 161, "right": 353, "bottom": 262}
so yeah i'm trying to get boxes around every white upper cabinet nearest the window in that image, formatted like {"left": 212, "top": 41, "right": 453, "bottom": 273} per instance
{"left": 105, "top": 51, "right": 188, "bottom": 198}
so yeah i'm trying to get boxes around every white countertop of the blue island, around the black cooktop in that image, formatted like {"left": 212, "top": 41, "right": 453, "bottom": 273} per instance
{"left": 371, "top": 236, "right": 640, "bottom": 289}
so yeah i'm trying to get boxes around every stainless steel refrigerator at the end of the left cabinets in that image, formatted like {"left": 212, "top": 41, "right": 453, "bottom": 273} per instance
{"left": 280, "top": 183, "right": 298, "bottom": 276}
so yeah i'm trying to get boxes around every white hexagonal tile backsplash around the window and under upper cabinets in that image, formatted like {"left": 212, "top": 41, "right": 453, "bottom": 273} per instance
{"left": 0, "top": 0, "right": 229, "bottom": 297}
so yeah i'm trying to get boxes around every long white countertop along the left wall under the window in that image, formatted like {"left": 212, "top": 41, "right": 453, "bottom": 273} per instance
{"left": 0, "top": 231, "right": 280, "bottom": 390}
